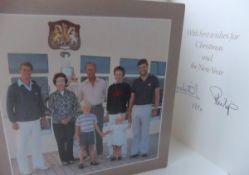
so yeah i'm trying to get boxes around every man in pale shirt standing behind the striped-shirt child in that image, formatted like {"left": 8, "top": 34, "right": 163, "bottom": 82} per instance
{"left": 80, "top": 63, "right": 107, "bottom": 155}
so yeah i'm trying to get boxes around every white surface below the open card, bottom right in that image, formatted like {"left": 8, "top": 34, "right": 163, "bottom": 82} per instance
{"left": 137, "top": 138, "right": 227, "bottom": 175}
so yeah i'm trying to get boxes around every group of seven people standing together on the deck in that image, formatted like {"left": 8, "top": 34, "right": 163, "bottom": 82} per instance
{"left": 6, "top": 59, "right": 165, "bottom": 175}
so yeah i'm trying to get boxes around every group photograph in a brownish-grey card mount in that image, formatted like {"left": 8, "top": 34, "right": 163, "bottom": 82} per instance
{"left": 0, "top": 0, "right": 184, "bottom": 175}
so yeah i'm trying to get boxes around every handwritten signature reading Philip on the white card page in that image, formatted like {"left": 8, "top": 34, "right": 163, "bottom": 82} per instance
{"left": 209, "top": 86, "right": 239, "bottom": 115}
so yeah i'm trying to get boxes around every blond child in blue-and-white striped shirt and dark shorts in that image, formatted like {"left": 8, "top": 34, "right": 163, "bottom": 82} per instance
{"left": 75, "top": 101, "right": 109, "bottom": 169}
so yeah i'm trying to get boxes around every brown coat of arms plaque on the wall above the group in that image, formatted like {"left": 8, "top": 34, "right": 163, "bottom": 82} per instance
{"left": 48, "top": 20, "right": 80, "bottom": 50}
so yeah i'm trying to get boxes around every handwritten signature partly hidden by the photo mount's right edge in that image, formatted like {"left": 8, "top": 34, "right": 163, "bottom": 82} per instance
{"left": 176, "top": 83, "right": 200, "bottom": 100}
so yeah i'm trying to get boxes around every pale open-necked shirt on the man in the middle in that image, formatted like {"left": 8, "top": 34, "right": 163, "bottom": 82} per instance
{"left": 80, "top": 78, "right": 107, "bottom": 105}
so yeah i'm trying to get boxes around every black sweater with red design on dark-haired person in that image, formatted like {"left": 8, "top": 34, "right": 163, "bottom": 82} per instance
{"left": 107, "top": 82, "right": 131, "bottom": 114}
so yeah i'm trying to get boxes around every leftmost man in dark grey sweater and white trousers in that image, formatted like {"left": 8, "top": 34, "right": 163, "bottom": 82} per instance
{"left": 7, "top": 62, "right": 48, "bottom": 174}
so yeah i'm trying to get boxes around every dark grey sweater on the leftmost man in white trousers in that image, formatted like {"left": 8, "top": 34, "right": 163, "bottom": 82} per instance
{"left": 7, "top": 80, "right": 45, "bottom": 122}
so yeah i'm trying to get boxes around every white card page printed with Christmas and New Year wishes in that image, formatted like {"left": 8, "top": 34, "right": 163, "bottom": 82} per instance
{"left": 170, "top": 0, "right": 249, "bottom": 175}
